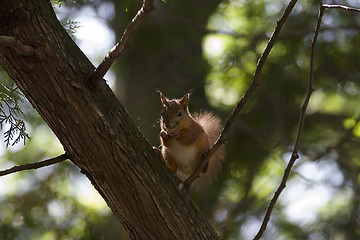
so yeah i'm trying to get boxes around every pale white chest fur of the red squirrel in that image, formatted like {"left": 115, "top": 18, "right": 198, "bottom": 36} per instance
{"left": 167, "top": 139, "right": 196, "bottom": 173}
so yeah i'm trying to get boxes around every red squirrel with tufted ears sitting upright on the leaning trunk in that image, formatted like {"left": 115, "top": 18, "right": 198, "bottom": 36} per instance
{"left": 154, "top": 91, "right": 224, "bottom": 188}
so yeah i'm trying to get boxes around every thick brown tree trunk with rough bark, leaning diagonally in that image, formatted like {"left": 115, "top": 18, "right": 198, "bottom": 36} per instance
{"left": 0, "top": 0, "right": 219, "bottom": 240}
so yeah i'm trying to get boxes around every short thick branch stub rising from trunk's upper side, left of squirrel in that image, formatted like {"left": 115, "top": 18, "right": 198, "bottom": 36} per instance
{"left": 88, "top": 0, "right": 154, "bottom": 87}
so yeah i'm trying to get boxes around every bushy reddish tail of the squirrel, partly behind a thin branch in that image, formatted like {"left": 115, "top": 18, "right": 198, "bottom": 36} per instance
{"left": 192, "top": 112, "right": 224, "bottom": 189}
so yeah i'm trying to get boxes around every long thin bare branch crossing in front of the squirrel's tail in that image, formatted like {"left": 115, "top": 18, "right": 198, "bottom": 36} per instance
{"left": 181, "top": 0, "right": 297, "bottom": 189}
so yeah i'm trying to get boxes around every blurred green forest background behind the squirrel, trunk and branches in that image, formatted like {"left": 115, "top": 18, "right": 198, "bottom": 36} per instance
{"left": 0, "top": 0, "right": 360, "bottom": 240}
